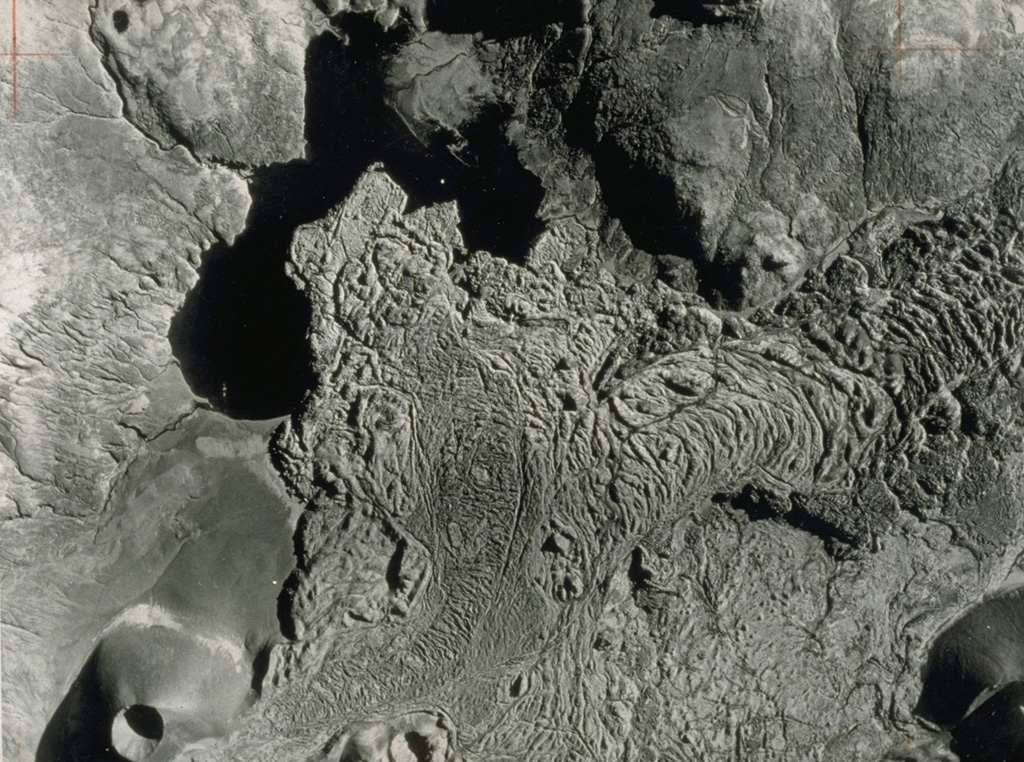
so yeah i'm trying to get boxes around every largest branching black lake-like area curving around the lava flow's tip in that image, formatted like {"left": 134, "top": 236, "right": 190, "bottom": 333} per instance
{"left": 169, "top": 25, "right": 544, "bottom": 420}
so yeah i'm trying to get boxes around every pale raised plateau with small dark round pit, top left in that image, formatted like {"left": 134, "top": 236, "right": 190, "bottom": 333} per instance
{"left": 92, "top": 0, "right": 311, "bottom": 166}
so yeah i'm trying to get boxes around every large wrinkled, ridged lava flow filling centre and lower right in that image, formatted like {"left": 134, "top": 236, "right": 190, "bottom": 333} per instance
{"left": 241, "top": 171, "right": 1024, "bottom": 759}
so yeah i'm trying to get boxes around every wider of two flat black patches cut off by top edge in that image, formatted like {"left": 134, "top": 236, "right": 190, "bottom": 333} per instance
{"left": 426, "top": 0, "right": 587, "bottom": 40}
